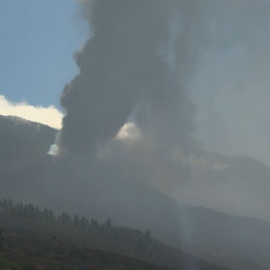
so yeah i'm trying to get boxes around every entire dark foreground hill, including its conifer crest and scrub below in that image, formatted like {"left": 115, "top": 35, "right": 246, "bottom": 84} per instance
{"left": 0, "top": 200, "right": 228, "bottom": 270}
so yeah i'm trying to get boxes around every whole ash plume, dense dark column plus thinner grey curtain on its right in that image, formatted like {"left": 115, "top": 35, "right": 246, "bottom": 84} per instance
{"left": 58, "top": 0, "right": 196, "bottom": 154}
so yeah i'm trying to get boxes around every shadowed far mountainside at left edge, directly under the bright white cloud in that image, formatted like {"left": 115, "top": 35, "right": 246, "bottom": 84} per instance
{"left": 0, "top": 115, "right": 56, "bottom": 172}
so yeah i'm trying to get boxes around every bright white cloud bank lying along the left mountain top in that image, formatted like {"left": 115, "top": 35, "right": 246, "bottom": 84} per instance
{"left": 0, "top": 95, "right": 63, "bottom": 129}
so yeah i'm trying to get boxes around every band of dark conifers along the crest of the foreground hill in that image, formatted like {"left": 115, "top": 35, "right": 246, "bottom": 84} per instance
{"left": 0, "top": 199, "right": 152, "bottom": 252}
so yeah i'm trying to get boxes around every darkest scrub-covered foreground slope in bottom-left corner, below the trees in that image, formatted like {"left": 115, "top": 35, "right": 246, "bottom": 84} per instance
{"left": 0, "top": 234, "right": 168, "bottom": 270}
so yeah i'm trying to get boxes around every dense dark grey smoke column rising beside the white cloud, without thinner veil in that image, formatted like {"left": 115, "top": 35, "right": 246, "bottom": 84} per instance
{"left": 60, "top": 0, "right": 194, "bottom": 154}
